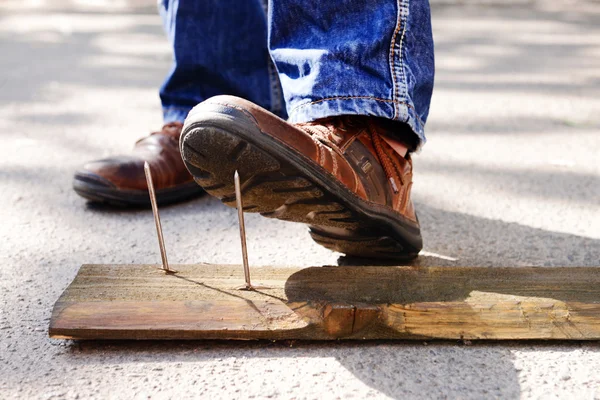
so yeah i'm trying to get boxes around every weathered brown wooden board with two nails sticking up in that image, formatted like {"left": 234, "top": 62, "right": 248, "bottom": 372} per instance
{"left": 49, "top": 264, "right": 600, "bottom": 340}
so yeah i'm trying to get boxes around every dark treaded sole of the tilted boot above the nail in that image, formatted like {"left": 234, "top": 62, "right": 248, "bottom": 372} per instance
{"left": 180, "top": 104, "right": 422, "bottom": 260}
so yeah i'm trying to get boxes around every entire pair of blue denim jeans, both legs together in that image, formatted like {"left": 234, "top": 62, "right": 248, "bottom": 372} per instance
{"left": 159, "top": 0, "right": 434, "bottom": 144}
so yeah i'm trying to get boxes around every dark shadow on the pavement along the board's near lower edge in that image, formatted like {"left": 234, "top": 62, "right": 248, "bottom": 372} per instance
{"left": 57, "top": 341, "right": 520, "bottom": 399}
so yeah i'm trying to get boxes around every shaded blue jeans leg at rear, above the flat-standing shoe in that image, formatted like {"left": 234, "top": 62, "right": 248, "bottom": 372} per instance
{"left": 158, "top": 0, "right": 285, "bottom": 123}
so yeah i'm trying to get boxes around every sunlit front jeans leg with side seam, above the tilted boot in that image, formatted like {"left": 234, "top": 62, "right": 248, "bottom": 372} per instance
{"left": 269, "top": 0, "right": 434, "bottom": 145}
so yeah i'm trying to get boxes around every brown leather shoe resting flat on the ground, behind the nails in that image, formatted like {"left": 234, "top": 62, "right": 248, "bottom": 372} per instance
{"left": 73, "top": 122, "right": 203, "bottom": 206}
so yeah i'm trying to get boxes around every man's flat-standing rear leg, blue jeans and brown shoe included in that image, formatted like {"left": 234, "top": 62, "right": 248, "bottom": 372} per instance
{"left": 73, "top": 0, "right": 285, "bottom": 205}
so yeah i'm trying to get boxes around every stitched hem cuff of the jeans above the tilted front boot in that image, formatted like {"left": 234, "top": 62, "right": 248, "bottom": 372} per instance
{"left": 288, "top": 96, "right": 427, "bottom": 149}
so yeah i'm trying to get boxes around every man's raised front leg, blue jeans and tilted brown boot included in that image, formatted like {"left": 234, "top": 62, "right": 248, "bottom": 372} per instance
{"left": 180, "top": 0, "right": 433, "bottom": 259}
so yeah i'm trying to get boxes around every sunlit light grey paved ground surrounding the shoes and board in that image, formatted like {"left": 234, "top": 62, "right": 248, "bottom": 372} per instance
{"left": 0, "top": 1, "right": 600, "bottom": 399}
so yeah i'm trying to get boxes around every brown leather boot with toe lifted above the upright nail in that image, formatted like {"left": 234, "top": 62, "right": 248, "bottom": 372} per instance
{"left": 180, "top": 96, "right": 422, "bottom": 259}
